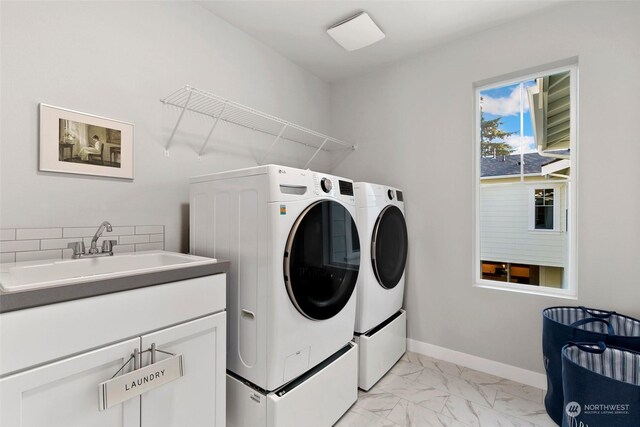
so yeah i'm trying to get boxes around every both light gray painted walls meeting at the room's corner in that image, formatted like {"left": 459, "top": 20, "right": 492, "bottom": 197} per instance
{"left": 0, "top": 2, "right": 640, "bottom": 372}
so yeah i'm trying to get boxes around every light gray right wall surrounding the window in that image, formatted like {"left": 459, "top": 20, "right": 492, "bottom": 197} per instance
{"left": 331, "top": 2, "right": 640, "bottom": 372}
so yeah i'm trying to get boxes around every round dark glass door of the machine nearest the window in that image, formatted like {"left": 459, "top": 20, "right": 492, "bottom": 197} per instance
{"left": 371, "top": 205, "right": 408, "bottom": 289}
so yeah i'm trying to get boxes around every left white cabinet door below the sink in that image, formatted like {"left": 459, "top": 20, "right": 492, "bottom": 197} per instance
{"left": 0, "top": 338, "right": 140, "bottom": 427}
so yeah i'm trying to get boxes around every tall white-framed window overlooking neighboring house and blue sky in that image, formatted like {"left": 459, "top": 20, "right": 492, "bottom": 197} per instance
{"left": 474, "top": 66, "right": 577, "bottom": 297}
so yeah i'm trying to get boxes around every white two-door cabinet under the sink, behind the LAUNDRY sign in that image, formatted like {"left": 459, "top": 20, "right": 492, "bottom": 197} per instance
{"left": 0, "top": 274, "right": 226, "bottom": 427}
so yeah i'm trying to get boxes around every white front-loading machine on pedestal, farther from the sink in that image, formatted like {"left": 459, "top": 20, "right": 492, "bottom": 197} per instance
{"left": 354, "top": 182, "right": 408, "bottom": 390}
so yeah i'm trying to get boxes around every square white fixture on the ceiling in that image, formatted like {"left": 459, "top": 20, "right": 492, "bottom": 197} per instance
{"left": 327, "top": 12, "right": 385, "bottom": 51}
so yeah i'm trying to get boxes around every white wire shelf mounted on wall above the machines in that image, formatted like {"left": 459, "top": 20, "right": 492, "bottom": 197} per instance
{"left": 161, "top": 85, "right": 357, "bottom": 169}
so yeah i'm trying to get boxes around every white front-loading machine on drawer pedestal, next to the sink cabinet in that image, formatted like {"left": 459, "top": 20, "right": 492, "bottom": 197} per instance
{"left": 190, "top": 165, "right": 360, "bottom": 425}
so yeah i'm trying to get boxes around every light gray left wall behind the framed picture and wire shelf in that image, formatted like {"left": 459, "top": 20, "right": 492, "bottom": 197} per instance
{"left": 0, "top": 1, "right": 330, "bottom": 251}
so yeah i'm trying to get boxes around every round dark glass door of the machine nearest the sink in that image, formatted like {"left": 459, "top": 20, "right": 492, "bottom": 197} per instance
{"left": 284, "top": 200, "right": 360, "bottom": 320}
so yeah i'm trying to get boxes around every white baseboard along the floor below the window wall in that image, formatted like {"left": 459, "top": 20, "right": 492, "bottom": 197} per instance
{"left": 407, "top": 338, "right": 547, "bottom": 390}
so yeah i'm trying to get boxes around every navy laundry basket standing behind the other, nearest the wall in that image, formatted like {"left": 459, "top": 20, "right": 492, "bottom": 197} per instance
{"left": 542, "top": 307, "right": 640, "bottom": 425}
